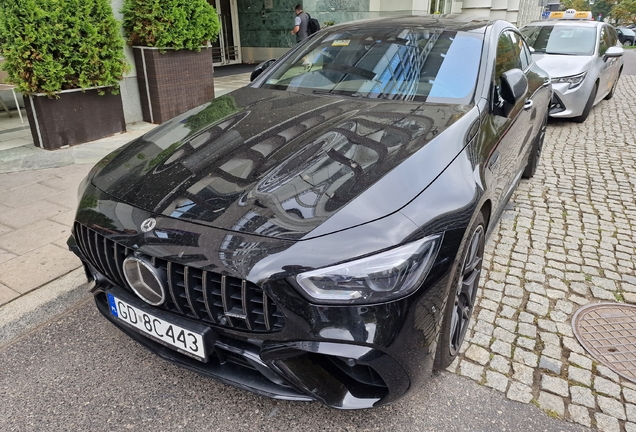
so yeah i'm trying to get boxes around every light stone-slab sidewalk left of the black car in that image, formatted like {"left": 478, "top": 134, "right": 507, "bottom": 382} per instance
{"left": 0, "top": 164, "right": 91, "bottom": 305}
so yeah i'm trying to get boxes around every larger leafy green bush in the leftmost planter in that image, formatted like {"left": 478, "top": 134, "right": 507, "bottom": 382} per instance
{"left": 0, "top": 0, "right": 127, "bottom": 95}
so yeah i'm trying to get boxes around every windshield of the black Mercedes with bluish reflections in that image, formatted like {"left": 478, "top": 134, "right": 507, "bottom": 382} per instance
{"left": 262, "top": 28, "right": 483, "bottom": 103}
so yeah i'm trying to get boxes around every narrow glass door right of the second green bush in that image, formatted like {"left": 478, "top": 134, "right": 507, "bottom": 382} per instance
{"left": 208, "top": 0, "right": 241, "bottom": 66}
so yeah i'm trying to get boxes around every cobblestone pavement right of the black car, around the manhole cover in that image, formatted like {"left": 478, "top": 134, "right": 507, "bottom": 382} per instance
{"left": 449, "top": 76, "right": 636, "bottom": 432}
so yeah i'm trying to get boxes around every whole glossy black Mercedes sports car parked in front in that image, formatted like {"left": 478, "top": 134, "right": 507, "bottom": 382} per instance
{"left": 69, "top": 16, "right": 552, "bottom": 408}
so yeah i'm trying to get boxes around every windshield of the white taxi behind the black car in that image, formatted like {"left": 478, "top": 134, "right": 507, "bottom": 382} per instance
{"left": 521, "top": 25, "right": 596, "bottom": 55}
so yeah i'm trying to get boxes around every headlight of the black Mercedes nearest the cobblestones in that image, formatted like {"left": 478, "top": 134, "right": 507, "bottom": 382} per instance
{"left": 290, "top": 234, "right": 443, "bottom": 304}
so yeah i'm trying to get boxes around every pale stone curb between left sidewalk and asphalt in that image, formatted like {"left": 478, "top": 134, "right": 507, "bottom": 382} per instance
{"left": 0, "top": 268, "right": 90, "bottom": 346}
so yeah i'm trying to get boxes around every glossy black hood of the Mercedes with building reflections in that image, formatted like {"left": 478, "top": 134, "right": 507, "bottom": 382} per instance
{"left": 92, "top": 87, "right": 476, "bottom": 240}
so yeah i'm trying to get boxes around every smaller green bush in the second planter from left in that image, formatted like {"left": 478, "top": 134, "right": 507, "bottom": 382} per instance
{"left": 121, "top": 0, "right": 221, "bottom": 51}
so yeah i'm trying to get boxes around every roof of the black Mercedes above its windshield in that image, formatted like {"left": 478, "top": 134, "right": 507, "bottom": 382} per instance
{"left": 329, "top": 14, "right": 501, "bottom": 32}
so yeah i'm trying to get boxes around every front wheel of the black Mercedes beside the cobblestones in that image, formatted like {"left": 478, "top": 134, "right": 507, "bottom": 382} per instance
{"left": 434, "top": 213, "right": 486, "bottom": 369}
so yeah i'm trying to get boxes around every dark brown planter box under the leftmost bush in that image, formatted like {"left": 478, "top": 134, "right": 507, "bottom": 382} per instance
{"left": 24, "top": 88, "right": 126, "bottom": 150}
